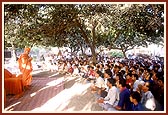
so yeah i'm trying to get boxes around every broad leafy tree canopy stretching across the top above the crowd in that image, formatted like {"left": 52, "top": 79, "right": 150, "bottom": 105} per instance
{"left": 4, "top": 3, "right": 165, "bottom": 61}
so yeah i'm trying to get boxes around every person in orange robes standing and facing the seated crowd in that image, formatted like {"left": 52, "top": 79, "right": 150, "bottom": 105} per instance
{"left": 18, "top": 48, "right": 33, "bottom": 89}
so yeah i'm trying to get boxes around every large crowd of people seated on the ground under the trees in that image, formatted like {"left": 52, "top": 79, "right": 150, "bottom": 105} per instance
{"left": 55, "top": 55, "right": 164, "bottom": 111}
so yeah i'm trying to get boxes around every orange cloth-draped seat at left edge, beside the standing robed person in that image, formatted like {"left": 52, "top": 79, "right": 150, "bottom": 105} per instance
{"left": 4, "top": 69, "right": 23, "bottom": 94}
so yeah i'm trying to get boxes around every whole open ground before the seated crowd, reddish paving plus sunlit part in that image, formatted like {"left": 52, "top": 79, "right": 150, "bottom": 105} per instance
{"left": 2, "top": 72, "right": 102, "bottom": 112}
